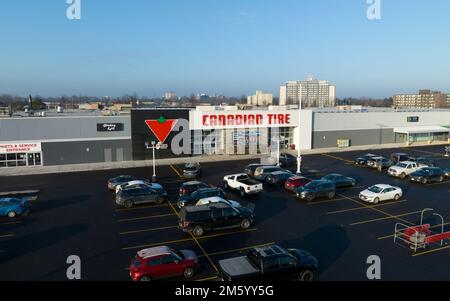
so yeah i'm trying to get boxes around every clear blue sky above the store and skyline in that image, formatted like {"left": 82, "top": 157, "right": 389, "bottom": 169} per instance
{"left": 0, "top": 0, "right": 450, "bottom": 98}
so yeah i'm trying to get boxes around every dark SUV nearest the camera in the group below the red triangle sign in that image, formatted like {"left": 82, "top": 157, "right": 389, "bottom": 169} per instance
{"left": 116, "top": 187, "right": 167, "bottom": 208}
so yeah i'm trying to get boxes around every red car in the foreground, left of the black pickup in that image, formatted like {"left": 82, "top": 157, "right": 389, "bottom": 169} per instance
{"left": 130, "top": 246, "right": 199, "bottom": 281}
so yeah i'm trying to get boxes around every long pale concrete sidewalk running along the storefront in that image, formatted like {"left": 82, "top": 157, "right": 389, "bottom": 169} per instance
{"left": 0, "top": 142, "right": 449, "bottom": 177}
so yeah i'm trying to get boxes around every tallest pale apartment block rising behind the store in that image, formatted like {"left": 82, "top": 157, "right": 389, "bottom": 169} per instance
{"left": 280, "top": 76, "right": 336, "bottom": 107}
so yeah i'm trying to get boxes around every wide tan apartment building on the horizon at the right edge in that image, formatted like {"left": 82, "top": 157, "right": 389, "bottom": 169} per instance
{"left": 393, "top": 90, "right": 450, "bottom": 109}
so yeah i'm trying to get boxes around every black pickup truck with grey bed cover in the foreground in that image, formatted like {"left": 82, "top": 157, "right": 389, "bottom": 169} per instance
{"left": 218, "top": 245, "right": 318, "bottom": 281}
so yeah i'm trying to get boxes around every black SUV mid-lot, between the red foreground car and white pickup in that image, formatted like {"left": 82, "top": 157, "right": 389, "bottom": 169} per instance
{"left": 178, "top": 203, "right": 254, "bottom": 236}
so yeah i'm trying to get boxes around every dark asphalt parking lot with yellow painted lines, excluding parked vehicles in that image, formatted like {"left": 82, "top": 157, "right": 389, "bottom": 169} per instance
{"left": 0, "top": 146, "right": 450, "bottom": 280}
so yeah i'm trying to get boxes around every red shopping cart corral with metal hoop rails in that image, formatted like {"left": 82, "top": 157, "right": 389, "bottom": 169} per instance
{"left": 394, "top": 208, "right": 450, "bottom": 252}
